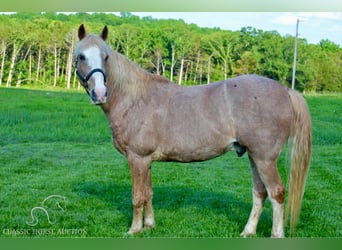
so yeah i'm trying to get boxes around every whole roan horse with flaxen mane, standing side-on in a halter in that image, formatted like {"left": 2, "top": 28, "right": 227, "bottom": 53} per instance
{"left": 74, "top": 24, "right": 312, "bottom": 237}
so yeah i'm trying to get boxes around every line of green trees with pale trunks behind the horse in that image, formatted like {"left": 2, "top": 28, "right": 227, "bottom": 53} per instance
{"left": 0, "top": 12, "right": 342, "bottom": 92}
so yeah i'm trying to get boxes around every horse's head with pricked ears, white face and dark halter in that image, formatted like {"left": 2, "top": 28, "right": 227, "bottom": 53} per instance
{"left": 75, "top": 24, "right": 109, "bottom": 104}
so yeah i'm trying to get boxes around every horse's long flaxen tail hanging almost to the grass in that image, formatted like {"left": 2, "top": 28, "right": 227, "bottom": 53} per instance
{"left": 285, "top": 90, "right": 312, "bottom": 234}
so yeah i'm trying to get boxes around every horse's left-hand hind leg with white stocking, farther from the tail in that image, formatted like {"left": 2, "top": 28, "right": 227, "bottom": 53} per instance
{"left": 240, "top": 157, "right": 267, "bottom": 237}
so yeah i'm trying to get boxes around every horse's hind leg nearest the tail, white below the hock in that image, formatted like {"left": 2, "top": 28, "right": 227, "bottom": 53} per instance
{"left": 253, "top": 158, "right": 285, "bottom": 238}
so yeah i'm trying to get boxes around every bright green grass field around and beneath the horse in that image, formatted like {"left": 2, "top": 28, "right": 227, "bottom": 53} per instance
{"left": 0, "top": 88, "right": 342, "bottom": 237}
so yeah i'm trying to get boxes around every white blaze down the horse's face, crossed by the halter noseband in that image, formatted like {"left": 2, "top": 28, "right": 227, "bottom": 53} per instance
{"left": 83, "top": 47, "right": 107, "bottom": 100}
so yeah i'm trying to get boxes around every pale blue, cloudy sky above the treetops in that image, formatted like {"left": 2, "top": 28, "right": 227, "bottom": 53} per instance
{"left": 130, "top": 12, "right": 342, "bottom": 48}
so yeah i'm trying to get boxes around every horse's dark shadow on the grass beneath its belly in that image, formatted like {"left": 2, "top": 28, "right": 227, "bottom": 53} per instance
{"left": 74, "top": 181, "right": 272, "bottom": 237}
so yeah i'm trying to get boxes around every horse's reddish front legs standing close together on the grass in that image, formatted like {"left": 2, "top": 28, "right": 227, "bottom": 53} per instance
{"left": 128, "top": 154, "right": 154, "bottom": 234}
